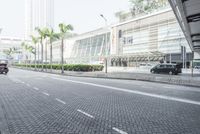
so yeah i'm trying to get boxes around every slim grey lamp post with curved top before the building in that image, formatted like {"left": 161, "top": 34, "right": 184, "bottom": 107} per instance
{"left": 100, "top": 14, "right": 108, "bottom": 73}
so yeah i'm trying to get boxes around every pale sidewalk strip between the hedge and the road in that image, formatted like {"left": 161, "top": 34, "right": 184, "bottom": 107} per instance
{"left": 12, "top": 67, "right": 200, "bottom": 87}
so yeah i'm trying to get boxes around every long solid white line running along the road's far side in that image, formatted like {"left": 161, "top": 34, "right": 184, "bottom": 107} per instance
{"left": 51, "top": 77, "right": 200, "bottom": 106}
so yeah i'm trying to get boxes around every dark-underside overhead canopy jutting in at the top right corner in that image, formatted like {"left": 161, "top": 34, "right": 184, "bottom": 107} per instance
{"left": 169, "top": 0, "right": 200, "bottom": 52}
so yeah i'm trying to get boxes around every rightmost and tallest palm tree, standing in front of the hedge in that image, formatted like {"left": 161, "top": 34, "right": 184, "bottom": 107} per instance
{"left": 59, "top": 23, "right": 73, "bottom": 74}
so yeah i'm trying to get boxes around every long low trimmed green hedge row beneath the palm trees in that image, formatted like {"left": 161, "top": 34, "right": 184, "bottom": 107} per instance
{"left": 15, "top": 64, "right": 103, "bottom": 72}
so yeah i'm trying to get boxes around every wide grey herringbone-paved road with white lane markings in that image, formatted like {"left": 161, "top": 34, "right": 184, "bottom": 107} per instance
{"left": 0, "top": 69, "right": 200, "bottom": 134}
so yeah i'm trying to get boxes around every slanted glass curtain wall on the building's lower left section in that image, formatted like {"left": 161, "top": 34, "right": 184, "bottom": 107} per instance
{"left": 67, "top": 33, "right": 110, "bottom": 64}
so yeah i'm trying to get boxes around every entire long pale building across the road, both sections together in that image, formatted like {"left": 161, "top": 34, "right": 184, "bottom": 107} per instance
{"left": 54, "top": 9, "right": 192, "bottom": 67}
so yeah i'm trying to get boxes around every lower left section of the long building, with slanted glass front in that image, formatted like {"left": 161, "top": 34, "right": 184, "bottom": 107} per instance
{"left": 53, "top": 28, "right": 111, "bottom": 64}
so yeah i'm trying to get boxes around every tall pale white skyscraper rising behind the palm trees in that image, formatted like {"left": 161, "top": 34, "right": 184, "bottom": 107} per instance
{"left": 25, "top": 0, "right": 54, "bottom": 39}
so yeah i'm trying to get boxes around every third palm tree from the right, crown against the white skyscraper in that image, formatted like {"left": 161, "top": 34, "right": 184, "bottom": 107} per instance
{"left": 35, "top": 27, "right": 46, "bottom": 71}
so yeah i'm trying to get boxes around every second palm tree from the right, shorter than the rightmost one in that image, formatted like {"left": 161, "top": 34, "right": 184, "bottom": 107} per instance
{"left": 46, "top": 28, "right": 59, "bottom": 72}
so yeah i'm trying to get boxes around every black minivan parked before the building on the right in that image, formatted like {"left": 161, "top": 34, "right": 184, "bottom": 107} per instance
{"left": 150, "top": 63, "right": 181, "bottom": 75}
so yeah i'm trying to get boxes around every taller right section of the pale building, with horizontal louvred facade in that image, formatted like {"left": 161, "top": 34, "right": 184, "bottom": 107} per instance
{"left": 111, "top": 9, "right": 192, "bottom": 66}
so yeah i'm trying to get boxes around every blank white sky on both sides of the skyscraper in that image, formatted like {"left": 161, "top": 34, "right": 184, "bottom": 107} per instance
{"left": 0, "top": 0, "right": 129, "bottom": 37}
